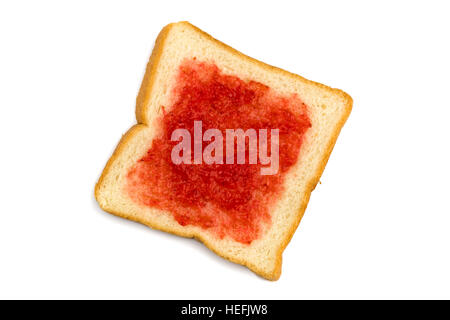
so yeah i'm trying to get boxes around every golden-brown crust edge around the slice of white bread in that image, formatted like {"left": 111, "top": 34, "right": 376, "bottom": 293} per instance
{"left": 95, "top": 21, "right": 353, "bottom": 280}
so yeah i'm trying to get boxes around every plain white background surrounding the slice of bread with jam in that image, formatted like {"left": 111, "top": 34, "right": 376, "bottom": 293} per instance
{"left": 0, "top": 0, "right": 450, "bottom": 299}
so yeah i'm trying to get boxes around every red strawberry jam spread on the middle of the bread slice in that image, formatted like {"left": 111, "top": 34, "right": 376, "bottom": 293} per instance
{"left": 125, "top": 58, "right": 311, "bottom": 244}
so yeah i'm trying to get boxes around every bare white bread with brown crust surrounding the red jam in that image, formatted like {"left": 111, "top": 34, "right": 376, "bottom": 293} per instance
{"left": 95, "top": 22, "right": 352, "bottom": 280}
